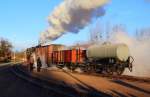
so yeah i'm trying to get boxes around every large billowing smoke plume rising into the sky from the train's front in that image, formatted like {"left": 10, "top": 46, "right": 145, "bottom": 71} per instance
{"left": 40, "top": 0, "right": 108, "bottom": 43}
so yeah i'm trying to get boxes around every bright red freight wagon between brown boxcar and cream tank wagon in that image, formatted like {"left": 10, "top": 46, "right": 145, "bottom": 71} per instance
{"left": 52, "top": 48, "right": 86, "bottom": 70}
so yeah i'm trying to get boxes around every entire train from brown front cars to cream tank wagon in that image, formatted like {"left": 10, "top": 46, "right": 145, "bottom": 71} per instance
{"left": 27, "top": 43, "right": 134, "bottom": 75}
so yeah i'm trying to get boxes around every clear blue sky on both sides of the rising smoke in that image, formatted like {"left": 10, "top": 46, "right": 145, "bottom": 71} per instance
{"left": 0, "top": 0, "right": 150, "bottom": 49}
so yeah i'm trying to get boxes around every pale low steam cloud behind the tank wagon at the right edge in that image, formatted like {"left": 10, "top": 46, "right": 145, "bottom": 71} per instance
{"left": 110, "top": 31, "right": 150, "bottom": 77}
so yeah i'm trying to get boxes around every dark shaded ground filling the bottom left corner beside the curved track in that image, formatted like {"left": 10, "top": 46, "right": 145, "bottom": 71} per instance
{"left": 0, "top": 66, "right": 47, "bottom": 97}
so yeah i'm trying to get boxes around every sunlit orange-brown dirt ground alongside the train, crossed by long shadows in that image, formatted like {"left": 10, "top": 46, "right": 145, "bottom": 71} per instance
{"left": 33, "top": 68, "right": 150, "bottom": 97}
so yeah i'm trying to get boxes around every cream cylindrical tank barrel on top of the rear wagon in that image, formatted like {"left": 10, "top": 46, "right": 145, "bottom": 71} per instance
{"left": 87, "top": 44, "right": 129, "bottom": 61}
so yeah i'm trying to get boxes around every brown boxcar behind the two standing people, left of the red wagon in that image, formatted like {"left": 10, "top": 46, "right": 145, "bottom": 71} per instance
{"left": 26, "top": 44, "right": 65, "bottom": 67}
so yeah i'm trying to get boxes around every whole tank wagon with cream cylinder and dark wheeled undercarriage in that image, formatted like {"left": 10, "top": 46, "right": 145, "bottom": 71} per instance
{"left": 86, "top": 43, "right": 134, "bottom": 75}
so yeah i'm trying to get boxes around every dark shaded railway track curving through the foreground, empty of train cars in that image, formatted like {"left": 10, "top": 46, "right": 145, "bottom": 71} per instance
{"left": 11, "top": 66, "right": 91, "bottom": 97}
